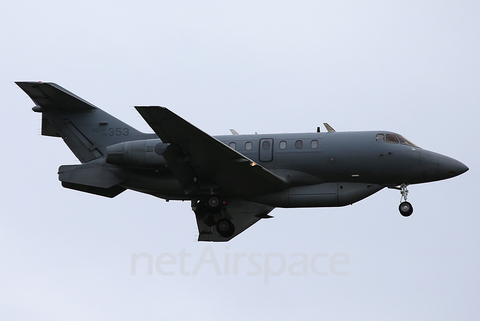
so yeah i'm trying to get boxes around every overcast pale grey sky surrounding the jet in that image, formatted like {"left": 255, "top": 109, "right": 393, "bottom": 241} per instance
{"left": 0, "top": 0, "right": 480, "bottom": 320}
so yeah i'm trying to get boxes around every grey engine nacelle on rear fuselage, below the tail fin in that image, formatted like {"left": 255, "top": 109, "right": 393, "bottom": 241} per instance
{"left": 107, "top": 139, "right": 169, "bottom": 168}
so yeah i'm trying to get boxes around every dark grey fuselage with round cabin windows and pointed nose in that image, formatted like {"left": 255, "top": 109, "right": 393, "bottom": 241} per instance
{"left": 113, "top": 131, "right": 468, "bottom": 204}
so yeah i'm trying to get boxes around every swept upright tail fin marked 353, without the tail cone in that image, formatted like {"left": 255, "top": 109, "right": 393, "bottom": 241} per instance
{"left": 16, "top": 82, "right": 154, "bottom": 163}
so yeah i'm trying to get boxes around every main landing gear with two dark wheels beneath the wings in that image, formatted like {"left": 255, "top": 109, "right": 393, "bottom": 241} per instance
{"left": 192, "top": 195, "right": 235, "bottom": 237}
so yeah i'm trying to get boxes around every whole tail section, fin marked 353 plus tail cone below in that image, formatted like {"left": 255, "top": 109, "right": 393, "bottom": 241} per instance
{"left": 16, "top": 82, "right": 156, "bottom": 197}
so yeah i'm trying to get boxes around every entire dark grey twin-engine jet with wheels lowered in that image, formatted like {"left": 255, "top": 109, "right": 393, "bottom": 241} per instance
{"left": 16, "top": 82, "right": 468, "bottom": 241}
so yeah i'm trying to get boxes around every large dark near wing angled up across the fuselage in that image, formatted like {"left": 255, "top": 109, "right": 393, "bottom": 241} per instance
{"left": 135, "top": 107, "right": 284, "bottom": 196}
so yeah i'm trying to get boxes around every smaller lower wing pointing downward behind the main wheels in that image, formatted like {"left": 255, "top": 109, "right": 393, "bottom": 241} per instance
{"left": 195, "top": 201, "right": 273, "bottom": 242}
